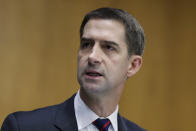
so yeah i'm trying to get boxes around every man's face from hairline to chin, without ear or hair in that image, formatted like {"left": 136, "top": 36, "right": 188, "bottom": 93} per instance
{"left": 77, "top": 19, "right": 130, "bottom": 93}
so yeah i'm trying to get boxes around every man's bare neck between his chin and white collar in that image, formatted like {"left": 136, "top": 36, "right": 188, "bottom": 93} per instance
{"left": 80, "top": 88, "right": 121, "bottom": 117}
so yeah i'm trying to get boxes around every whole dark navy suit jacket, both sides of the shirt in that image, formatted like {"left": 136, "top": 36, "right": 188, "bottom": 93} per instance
{"left": 1, "top": 95, "right": 145, "bottom": 131}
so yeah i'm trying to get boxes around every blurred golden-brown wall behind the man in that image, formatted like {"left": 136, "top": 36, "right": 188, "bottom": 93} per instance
{"left": 0, "top": 0, "right": 196, "bottom": 131}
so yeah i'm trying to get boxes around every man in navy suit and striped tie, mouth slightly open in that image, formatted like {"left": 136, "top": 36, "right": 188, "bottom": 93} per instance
{"left": 1, "top": 8, "right": 145, "bottom": 131}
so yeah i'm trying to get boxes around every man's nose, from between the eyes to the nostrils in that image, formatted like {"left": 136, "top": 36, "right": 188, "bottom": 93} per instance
{"left": 88, "top": 43, "right": 102, "bottom": 65}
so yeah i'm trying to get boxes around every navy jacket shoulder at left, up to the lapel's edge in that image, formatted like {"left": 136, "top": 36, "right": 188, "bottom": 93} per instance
{"left": 1, "top": 105, "right": 58, "bottom": 131}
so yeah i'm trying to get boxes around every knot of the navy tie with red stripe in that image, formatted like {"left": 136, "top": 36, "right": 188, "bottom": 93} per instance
{"left": 93, "top": 118, "right": 111, "bottom": 131}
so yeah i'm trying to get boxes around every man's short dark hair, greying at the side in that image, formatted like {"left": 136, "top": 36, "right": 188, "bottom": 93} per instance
{"left": 80, "top": 8, "right": 145, "bottom": 56}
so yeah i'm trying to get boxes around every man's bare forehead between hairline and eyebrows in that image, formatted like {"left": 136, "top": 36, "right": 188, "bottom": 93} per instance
{"left": 82, "top": 19, "right": 125, "bottom": 43}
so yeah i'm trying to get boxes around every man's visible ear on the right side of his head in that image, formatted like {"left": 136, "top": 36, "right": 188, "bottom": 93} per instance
{"left": 127, "top": 55, "right": 142, "bottom": 77}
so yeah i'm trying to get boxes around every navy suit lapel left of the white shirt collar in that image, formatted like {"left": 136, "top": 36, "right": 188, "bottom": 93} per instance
{"left": 54, "top": 94, "right": 78, "bottom": 131}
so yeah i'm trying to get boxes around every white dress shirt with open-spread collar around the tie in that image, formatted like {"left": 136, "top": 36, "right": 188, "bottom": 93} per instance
{"left": 74, "top": 90, "right": 118, "bottom": 131}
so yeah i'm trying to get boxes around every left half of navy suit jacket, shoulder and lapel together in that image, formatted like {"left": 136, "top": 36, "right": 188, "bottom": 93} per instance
{"left": 1, "top": 95, "right": 76, "bottom": 131}
